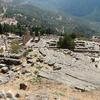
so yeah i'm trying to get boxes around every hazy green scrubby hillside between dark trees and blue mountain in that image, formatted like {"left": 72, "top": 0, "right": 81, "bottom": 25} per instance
{"left": 5, "top": 1, "right": 99, "bottom": 35}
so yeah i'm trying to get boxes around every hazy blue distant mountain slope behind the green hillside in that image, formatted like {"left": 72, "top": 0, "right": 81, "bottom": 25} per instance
{"left": 20, "top": 0, "right": 100, "bottom": 21}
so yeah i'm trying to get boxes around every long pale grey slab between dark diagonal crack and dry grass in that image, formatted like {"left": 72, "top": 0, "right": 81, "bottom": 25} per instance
{"left": 39, "top": 71, "right": 98, "bottom": 91}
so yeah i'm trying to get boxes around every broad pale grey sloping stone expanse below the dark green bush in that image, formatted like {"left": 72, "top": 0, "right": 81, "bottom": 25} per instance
{"left": 39, "top": 47, "right": 100, "bottom": 91}
